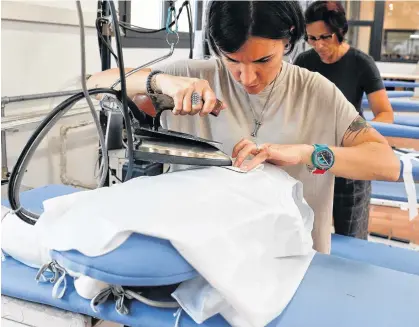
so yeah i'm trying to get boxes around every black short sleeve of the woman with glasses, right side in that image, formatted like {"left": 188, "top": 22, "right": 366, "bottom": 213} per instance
{"left": 358, "top": 54, "right": 384, "bottom": 94}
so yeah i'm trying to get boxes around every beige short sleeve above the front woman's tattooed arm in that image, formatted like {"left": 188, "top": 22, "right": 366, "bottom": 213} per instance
{"left": 314, "top": 73, "right": 359, "bottom": 146}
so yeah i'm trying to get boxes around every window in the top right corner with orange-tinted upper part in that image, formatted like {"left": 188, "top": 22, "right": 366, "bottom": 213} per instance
{"left": 380, "top": 1, "right": 419, "bottom": 62}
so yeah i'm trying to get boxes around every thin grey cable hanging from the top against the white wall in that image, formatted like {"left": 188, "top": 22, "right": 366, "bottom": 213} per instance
{"left": 76, "top": 0, "right": 109, "bottom": 187}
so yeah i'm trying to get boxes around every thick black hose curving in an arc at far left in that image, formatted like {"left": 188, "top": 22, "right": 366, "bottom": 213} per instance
{"left": 8, "top": 88, "right": 130, "bottom": 225}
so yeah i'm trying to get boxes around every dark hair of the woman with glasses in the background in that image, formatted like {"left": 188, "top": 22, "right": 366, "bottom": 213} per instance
{"left": 305, "top": 1, "right": 348, "bottom": 43}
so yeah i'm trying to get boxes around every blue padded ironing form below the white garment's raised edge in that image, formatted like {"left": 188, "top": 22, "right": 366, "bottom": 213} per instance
{"left": 51, "top": 233, "right": 197, "bottom": 286}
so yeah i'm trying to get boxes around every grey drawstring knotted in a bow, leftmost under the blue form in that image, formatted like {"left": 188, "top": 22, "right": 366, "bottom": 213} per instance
{"left": 35, "top": 261, "right": 67, "bottom": 299}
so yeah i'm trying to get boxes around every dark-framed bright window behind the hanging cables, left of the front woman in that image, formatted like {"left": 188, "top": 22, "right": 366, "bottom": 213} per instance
{"left": 119, "top": 0, "right": 202, "bottom": 48}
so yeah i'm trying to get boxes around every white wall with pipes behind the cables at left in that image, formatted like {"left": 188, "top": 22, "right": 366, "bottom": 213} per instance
{"left": 1, "top": 0, "right": 189, "bottom": 192}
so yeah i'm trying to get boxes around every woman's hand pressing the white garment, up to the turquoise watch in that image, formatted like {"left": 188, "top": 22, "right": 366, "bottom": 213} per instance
{"left": 232, "top": 139, "right": 313, "bottom": 171}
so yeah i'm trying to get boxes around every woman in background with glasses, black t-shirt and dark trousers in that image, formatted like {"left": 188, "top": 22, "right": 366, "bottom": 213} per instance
{"left": 295, "top": 1, "right": 394, "bottom": 239}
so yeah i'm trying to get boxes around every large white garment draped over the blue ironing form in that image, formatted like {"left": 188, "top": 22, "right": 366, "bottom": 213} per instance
{"left": 36, "top": 164, "right": 313, "bottom": 327}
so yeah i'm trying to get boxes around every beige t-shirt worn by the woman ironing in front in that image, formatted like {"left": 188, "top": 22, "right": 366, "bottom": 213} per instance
{"left": 153, "top": 58, "right": 358, "bottom": 253}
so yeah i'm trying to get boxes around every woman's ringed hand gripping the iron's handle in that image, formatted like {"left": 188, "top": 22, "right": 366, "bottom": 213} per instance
{"left": 156, "top": 74, "right": 226, "bottom": 116}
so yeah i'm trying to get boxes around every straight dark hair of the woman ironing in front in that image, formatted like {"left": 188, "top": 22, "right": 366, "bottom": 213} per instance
{"left": 206, "top": 1, "right": 304, "bottom": 56}
